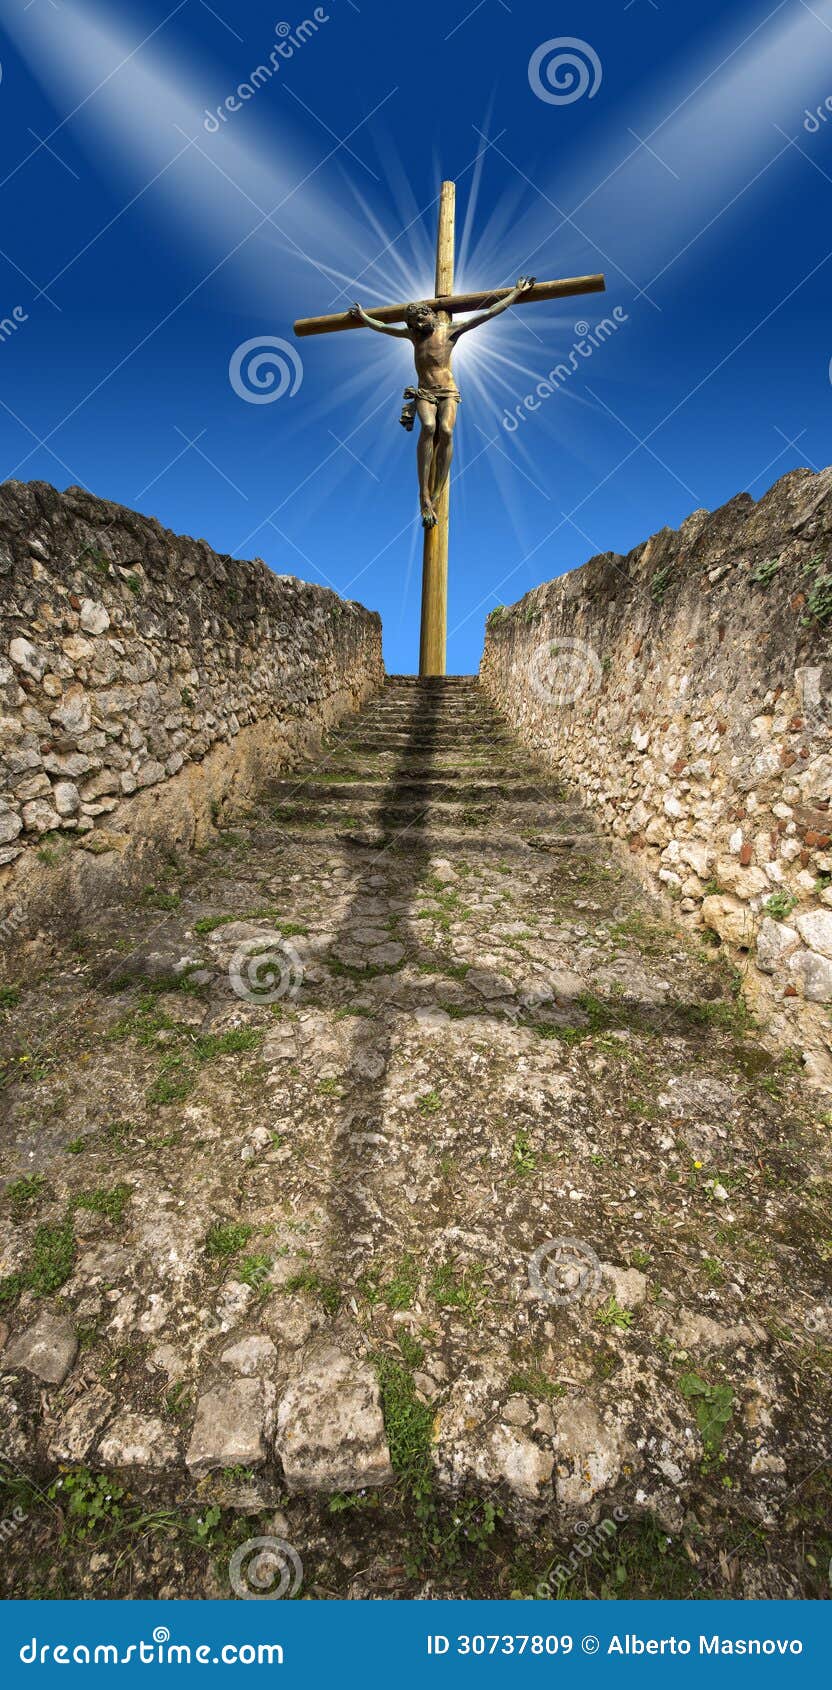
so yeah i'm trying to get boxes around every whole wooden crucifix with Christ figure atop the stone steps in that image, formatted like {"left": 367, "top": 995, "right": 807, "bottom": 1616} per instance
{"left": 294, "top": 183, "right": 605, "bottom": 676}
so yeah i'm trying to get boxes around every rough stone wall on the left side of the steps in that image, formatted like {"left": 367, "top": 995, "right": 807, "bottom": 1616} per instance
{"left": 0, "top": 482, "right": 384, "bottom": 950}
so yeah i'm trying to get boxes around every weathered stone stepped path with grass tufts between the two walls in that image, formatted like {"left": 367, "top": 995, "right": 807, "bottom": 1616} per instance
{"left": 0, "top": 679, "right": 832, "bottom": 1597}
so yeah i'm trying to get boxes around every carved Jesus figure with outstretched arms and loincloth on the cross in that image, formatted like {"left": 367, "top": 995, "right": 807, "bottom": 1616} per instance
{"left": 350, "top": 275, "right": 534, "bottom": 529}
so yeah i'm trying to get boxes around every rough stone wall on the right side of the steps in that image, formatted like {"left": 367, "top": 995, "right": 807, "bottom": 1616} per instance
{"left": 480, "top": 470, "right": 832, "bottom": 1078}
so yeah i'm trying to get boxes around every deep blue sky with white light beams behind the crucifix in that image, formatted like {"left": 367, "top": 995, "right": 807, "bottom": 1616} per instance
{"left": 0, "top": 0, "right": 832, "bottom": 673}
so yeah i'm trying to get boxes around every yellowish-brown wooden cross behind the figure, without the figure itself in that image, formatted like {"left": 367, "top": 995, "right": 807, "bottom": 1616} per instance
{"left": 294, "top": 183, "right": 605, "bottom": 676}
